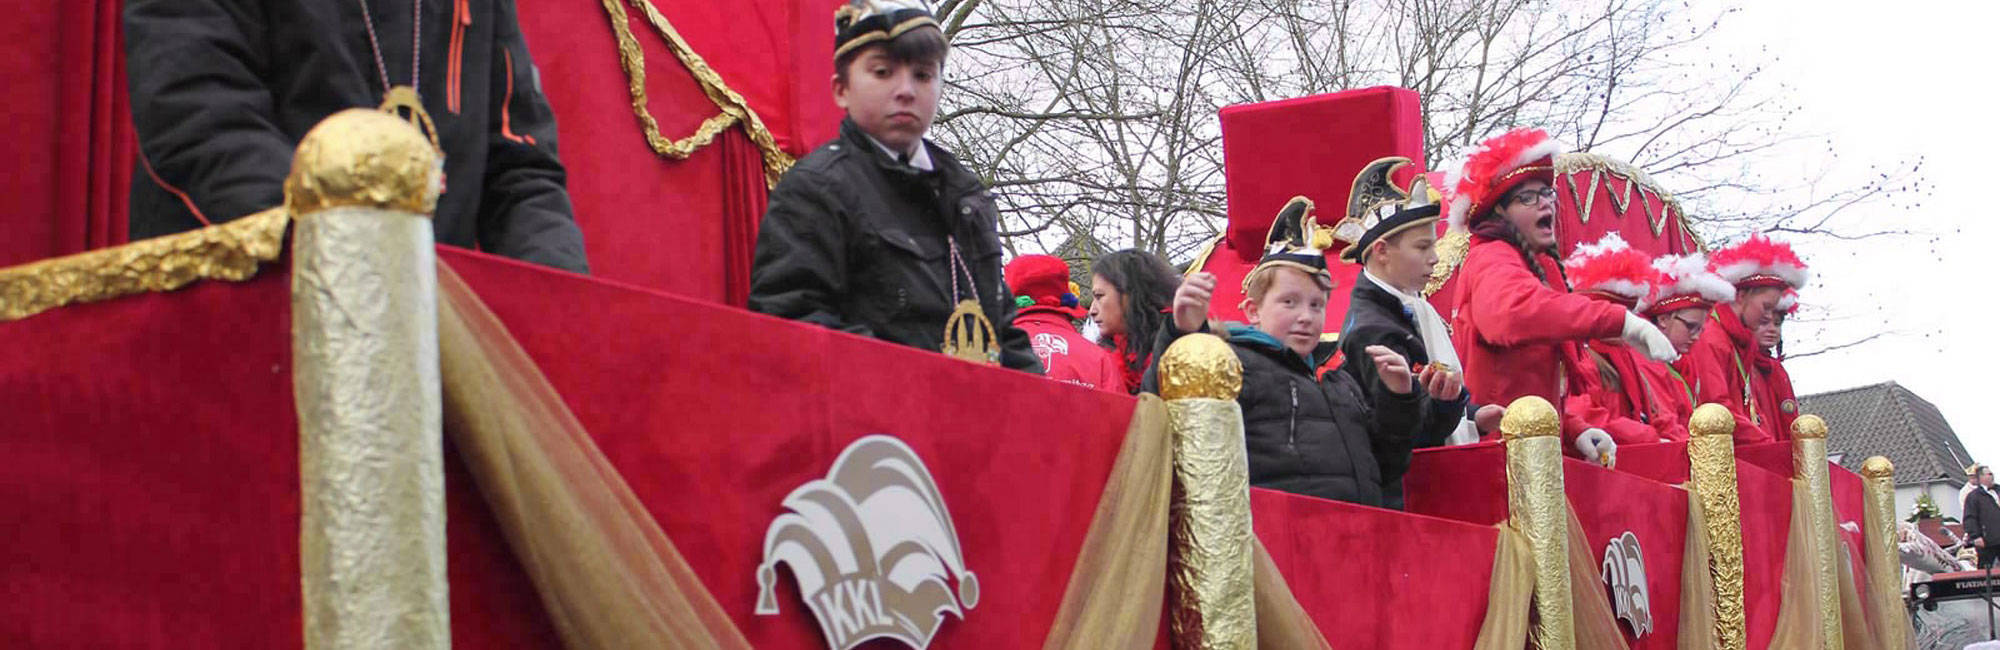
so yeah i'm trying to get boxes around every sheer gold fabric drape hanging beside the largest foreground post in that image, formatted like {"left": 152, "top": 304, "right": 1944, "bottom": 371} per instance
{"left": 438, "top": 264, "right": 750, "bottom": 650}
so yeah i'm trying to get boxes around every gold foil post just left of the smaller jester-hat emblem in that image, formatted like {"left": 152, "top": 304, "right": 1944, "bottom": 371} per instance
{"left": 1500, "top": 396, "right": 1576, "bottom": 650}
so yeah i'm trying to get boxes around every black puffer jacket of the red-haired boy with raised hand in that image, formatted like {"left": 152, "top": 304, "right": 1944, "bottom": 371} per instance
{"left": 1146, "top": 324, "right": 1424, "bottom": 506}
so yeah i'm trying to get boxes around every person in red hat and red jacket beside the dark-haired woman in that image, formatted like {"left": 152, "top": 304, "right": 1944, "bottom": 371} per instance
{"left": 1006, "top": 256, "right": 1124, "bottom": 392}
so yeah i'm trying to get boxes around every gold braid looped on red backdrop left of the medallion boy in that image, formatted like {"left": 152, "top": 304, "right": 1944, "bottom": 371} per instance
{"left": 602, "top": 0, "right": 794, "bottom": 186}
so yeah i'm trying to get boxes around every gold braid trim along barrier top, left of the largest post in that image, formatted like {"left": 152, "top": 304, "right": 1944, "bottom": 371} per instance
{"left": 0, "top": 208, "right": 292, "bottom": 322}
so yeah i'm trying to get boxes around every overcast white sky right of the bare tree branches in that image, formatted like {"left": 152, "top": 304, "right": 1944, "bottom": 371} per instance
{"left": 1704, "top": 0, "right": 2000, "bottom": 462}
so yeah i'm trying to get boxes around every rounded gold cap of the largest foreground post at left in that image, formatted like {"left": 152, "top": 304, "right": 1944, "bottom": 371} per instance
{"left": 284, "top": 108, "right": 444, "bottom": 216}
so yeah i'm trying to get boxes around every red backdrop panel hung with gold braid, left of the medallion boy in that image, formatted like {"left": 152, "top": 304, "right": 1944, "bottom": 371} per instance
{"left": 518, "top": 0, "right": 840, "bottom": 304}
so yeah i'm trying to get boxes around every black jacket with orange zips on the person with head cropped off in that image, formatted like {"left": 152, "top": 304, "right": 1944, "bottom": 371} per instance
{"left": 124, "top": 0, "right": 588, "bottom": 272}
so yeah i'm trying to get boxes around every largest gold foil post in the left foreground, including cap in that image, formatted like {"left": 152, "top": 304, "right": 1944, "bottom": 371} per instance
{"left": 284, "top": 110, "right": 452, "bottom": 650}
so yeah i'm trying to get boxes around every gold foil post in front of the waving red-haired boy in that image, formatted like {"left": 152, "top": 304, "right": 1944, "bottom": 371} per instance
{"left": 1160, "top": 334, "right": 1256, "bottom": 650}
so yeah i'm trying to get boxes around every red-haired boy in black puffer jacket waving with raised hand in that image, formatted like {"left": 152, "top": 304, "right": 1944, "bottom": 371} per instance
{"left": 1148, "top": 198, "right": 1436, "bottom": 506}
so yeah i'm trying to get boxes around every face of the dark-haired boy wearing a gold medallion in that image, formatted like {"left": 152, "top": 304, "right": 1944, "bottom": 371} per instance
{"left": 834, "top": 46, "right": 942, "bottom": 152}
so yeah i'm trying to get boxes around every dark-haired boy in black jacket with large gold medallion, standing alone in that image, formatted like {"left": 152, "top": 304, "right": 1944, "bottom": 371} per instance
{"left": 750, "top": 0, "right": 1042, "bottom": 374}
